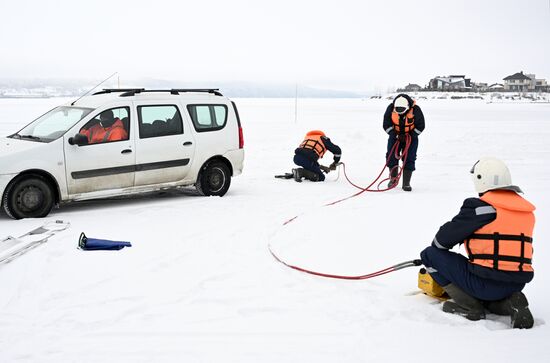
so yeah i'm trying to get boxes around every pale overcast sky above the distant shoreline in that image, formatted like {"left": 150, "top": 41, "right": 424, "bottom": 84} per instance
{"left": 0, "top": 0, "right": 550, "bottom": 91}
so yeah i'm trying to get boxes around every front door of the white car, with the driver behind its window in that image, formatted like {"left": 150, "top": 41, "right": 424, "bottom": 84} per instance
{"left": 64, "top": 105, "right": 136, "bottom": 196}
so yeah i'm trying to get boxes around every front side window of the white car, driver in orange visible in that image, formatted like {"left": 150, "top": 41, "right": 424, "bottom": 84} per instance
{"left": 79, "top": 107, "right": 130, "bottom": 144}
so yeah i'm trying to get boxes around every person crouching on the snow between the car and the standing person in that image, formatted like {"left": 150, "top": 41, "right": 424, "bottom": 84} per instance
{"left": 292, "top": 130, "right": 342, "bottom": 182}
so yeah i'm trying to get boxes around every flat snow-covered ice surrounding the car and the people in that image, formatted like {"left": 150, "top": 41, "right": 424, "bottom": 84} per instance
{"left": 0, "top": 99, "right": 550, "bottom": 363}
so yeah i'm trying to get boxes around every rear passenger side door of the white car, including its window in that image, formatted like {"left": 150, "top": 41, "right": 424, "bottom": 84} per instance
{"left": 135, "top": 101, "right": 195, "bottom": 187}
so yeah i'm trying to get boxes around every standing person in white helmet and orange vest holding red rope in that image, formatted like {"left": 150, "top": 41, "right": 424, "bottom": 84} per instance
{"left": 382, "top": 93, "right": 425, "bottom": 192}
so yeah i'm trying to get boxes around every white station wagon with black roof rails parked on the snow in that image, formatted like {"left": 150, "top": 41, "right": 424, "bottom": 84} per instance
{"left": 0, "top": 88, "right": 244, "bottom": 219}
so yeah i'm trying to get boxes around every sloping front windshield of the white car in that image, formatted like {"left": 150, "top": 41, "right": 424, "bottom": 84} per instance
{"left": 10, "top": 106, "right": 93, "bottom": 142}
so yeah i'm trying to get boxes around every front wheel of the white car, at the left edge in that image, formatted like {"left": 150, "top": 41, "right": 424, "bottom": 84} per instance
{"left": 2, "top": 175, "right": 54, "bottom": 219}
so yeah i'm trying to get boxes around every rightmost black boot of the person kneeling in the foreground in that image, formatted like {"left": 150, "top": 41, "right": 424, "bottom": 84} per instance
{"left": 487, "top": 292, "right": 534, "bottom": 329}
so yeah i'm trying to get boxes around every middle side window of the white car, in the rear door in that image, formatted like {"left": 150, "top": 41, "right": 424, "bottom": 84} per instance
{"left": 138, "top": 105, "right": 183, "bottom": 139}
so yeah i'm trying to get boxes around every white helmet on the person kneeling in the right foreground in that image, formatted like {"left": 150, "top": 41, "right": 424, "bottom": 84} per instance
{"left": 470, "top": 157, "right": 523, "bottom": 194}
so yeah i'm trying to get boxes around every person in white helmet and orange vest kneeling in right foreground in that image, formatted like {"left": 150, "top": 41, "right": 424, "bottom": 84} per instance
{"left": 420, "top": 158, "right": 535, "bottom": 328}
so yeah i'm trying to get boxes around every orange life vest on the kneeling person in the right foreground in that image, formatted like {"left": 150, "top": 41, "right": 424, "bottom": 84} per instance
{"left": 465, "top": 190, "right": 535, "bottom": 271}
